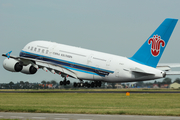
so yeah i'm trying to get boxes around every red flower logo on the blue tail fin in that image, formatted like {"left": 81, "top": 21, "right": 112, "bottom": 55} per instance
{"left": 148, "top": 35, "right": 165, "bottom": 57}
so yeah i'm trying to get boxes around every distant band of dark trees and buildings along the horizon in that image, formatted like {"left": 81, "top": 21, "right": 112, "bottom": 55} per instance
{"left": 0, "top": 77, "right": 180, "bottom": 89}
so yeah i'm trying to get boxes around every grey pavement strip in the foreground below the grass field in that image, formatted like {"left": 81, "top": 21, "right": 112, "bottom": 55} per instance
{"left": 0, "top": 112, "right": 180, "bottom": 120}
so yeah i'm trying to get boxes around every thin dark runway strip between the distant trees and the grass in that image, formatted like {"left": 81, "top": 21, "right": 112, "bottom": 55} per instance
{"left": 0, "top": 90, "right": 180, "bottom": 93}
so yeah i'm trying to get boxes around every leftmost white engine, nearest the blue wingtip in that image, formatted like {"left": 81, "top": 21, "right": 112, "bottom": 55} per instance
{"left": 3, "top": 58, "right": 23, "bottom": 72}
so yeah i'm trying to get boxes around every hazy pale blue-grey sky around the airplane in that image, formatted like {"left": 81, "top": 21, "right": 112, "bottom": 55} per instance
{"left": 0, "top": 0, "right": 180, "bottom": 83}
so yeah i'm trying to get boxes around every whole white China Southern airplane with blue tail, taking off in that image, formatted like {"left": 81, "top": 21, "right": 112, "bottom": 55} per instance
{"left": 2, "top": 18, "right": 178, "bottom": 87}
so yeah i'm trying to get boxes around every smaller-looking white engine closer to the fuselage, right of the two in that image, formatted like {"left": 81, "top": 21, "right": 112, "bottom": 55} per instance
{"left": 21, "top": 64, "right": 37, "bottom": 74}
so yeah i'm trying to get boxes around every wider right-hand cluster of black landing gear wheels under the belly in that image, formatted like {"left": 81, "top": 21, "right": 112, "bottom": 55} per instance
{"left": 73, "top": 81, "right": 101, "bottom": 88}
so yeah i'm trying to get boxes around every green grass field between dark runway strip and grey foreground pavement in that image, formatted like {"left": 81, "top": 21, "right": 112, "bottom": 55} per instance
{"left": 0, "top": 93, "right": 180, "bottom": 116}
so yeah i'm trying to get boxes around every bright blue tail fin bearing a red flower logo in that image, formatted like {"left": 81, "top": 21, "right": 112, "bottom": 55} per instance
{"left": 130, "top": 18, "right": 178, "bottom": 68}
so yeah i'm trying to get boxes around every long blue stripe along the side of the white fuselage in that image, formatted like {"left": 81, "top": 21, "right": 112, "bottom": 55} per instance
{"left": 20, "top": 50, "right": 114, "bottom": 76}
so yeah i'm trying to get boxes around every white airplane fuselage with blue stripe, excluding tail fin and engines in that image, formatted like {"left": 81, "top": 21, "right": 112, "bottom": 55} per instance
{"left": 21, "top": 41, "right": 164, "bottom": 82}
